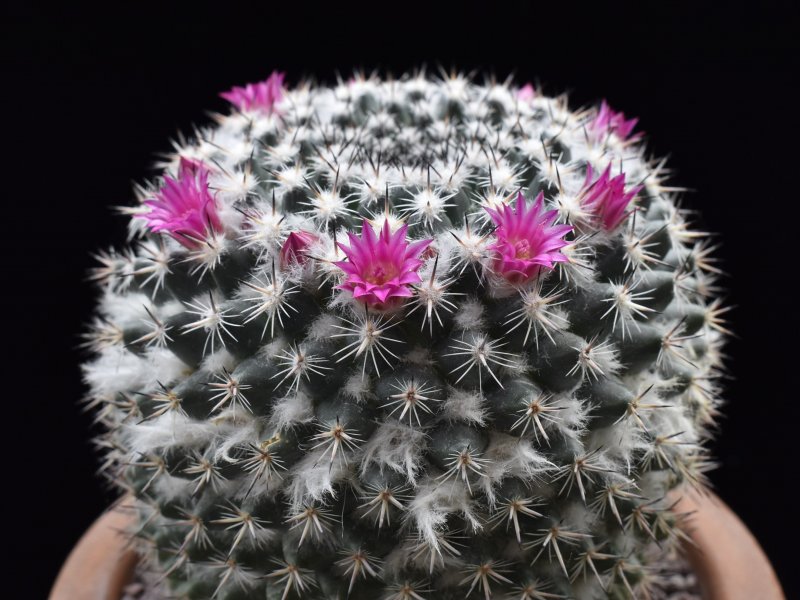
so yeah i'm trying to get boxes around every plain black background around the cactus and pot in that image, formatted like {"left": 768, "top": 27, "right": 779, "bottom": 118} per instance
{"left": 0, "top": 1, "right": 800, "bottom": 598}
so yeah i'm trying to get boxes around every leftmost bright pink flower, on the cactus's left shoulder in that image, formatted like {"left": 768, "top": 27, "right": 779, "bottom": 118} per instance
{"left": 141, "top": 158, "right": 223, "bottom": 248}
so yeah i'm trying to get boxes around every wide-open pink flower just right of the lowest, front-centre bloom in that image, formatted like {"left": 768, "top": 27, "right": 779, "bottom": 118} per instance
{"left": 486, "top": 192, "right": 572, "bottom": 284}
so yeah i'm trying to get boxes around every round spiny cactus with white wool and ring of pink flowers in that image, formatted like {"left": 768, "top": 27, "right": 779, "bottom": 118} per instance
{"left": 84, "top": 72, "right": 726, "bottom": 600}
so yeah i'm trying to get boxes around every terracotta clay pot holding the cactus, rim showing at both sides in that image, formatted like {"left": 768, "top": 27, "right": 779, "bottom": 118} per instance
{"left": 50, "top": 494, "right": 785, "bottom": 600}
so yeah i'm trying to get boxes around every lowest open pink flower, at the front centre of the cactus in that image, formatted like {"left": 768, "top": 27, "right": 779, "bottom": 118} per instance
{"left": 334, "top": 219, "right": 433, "bottom": 309}
